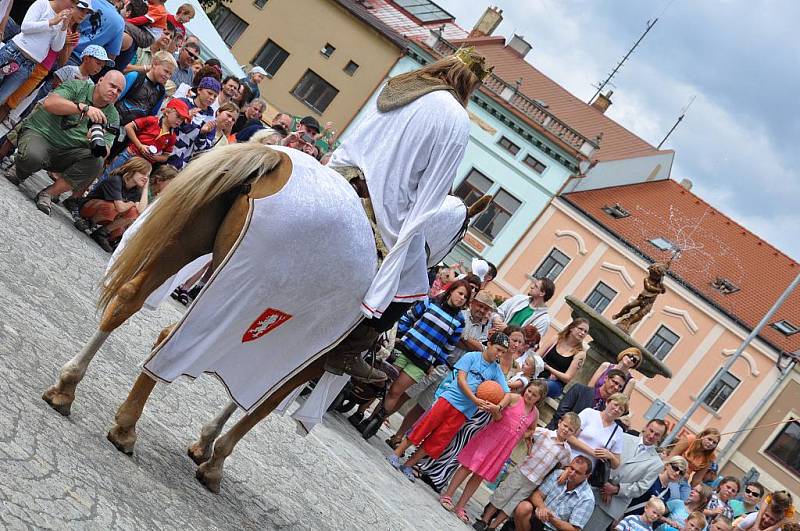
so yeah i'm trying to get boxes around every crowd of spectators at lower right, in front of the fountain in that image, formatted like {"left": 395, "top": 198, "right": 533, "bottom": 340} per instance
{"left": 349, "top": 266, "right": 794, "bottom": 531}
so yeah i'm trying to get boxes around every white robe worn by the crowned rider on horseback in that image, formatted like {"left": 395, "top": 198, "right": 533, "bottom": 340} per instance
{"left": 330, "top": 90, "right": 469, "bottom": 317}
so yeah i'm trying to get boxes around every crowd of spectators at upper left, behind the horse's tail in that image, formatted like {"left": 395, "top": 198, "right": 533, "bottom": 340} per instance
{"left": 0, "top": 0, "right": 335, "bottom": 252}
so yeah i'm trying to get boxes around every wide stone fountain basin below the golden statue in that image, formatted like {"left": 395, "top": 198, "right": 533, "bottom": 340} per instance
{"left": 565, "top": 295, "right": 672, "bottom": 381}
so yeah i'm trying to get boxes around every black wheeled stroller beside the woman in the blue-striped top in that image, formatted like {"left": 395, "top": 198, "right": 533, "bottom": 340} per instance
{"left": 328, "top": 342, "right": 400, "bottom": 439}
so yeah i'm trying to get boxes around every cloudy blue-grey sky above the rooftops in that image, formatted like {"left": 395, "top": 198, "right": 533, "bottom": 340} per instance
{"left": 435, "top": 0, "right": 800, "bottom": 260}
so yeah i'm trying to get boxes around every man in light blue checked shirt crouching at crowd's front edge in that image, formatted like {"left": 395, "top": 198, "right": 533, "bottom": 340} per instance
{"left": 514, "top": 455, "right": 595, "bottom": 531}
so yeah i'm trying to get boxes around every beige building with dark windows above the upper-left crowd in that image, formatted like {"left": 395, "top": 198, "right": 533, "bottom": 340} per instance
{"left": 209, "top": 0, "right": 405, "bottom": 130}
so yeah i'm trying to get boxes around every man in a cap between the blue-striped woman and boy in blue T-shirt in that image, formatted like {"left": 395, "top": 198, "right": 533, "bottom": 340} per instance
{"left": 378, "top": 291, "right": 495, "bottom": 448}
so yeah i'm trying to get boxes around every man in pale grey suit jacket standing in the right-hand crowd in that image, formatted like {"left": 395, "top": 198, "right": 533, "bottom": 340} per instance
{"left": 583, "top": 419, "right": 667, "bottom": 531}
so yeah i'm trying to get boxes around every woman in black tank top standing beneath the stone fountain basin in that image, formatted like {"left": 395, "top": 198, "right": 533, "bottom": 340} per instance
{"left": 537, "top": 317, "right": 589, "bottom": 398}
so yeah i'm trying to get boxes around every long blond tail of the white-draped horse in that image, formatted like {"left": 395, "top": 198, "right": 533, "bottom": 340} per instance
{"left": 98, "top": 143, "right": 281, "bottom": 309}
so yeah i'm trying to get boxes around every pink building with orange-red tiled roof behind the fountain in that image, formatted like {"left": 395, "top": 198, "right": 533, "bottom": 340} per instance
{"left": 495, "top": 179, "right": 800, "bottom": 495}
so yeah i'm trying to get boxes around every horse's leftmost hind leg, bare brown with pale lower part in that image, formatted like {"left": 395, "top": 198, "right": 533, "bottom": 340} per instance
{"left": 42, "top": 193, "right": 230, "bottom": 416}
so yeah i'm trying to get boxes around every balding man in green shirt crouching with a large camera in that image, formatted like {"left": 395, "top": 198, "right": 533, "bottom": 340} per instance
{"left": 9, "top": 70, "right": 125, "bottom": 215}
